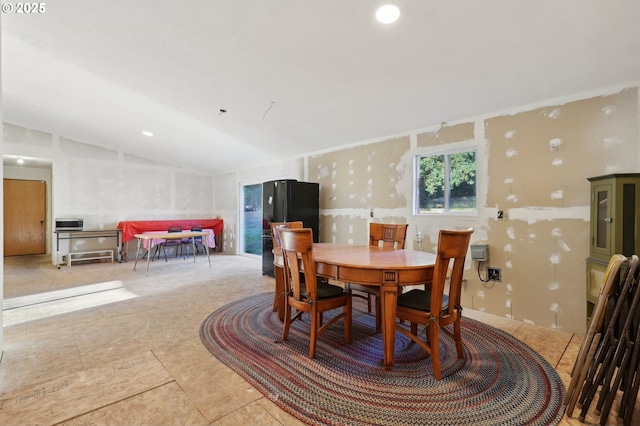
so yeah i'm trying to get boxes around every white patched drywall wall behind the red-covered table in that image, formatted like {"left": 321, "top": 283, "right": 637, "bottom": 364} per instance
{"left": 3, "top": 123, "right": 219, "bottom": 263}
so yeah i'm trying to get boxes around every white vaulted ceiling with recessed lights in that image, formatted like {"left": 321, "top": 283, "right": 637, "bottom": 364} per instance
{"left": 1, "top": 0, "right": 640, "bottom": 173}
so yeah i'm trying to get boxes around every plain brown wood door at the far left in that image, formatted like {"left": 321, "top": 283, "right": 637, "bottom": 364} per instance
{"left": 4, "top": 179, "right": 47, "bottom": 256}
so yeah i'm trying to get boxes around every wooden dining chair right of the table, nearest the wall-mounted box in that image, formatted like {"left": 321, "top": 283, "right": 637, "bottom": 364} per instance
{"left": 396, "top": 229, "right": 473, "bottom": 380}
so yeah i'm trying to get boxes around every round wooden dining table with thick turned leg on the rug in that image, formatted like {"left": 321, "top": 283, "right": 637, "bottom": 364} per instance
{"left": 273, "top": 243, "right": 436, "bottom": 369}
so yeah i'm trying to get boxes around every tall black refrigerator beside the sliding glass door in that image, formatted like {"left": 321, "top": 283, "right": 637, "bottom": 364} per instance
{"left": 262, "top": 180, "right": 320, "bottom": 276}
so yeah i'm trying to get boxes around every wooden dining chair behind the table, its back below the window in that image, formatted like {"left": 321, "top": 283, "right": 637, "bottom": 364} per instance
{"left": 346, "top": 223, "right": 409, "bottom": 331}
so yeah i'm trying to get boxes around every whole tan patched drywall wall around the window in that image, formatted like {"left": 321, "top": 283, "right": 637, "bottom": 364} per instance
{"left": 219, "top": 86, "right": 640, "bottom": 332}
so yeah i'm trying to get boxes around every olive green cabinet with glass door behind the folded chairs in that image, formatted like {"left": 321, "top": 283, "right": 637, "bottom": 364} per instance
{"left": 587, "top": 173, "right": 640, "bottom": 315}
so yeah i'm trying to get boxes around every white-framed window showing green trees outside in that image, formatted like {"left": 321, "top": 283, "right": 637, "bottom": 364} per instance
{"left": 414, "top": 147, "right": 478, "bottom": 215}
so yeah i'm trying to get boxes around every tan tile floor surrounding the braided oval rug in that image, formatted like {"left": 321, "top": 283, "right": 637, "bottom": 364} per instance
{"left": 0, "top": 253, "right": 640, "bottom": 425}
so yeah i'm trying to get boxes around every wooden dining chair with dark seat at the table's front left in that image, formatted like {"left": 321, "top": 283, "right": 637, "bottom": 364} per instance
{"left": 278, "top": 228, "right": 351, "bottom": 358}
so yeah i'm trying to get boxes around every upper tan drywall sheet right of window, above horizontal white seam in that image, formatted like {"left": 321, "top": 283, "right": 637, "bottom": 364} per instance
{"left": 485, "top": 89, "right": 638, "bottom": 208}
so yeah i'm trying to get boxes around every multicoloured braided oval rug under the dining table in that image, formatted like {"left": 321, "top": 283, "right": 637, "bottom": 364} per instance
{"left": 200, "top": 293, "right": 565, "bottom": 426}
